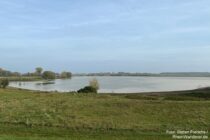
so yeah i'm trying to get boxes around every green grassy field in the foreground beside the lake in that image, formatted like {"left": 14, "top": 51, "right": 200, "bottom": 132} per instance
{"left": 0, "top": 88, "right": 210, "bottom": 140}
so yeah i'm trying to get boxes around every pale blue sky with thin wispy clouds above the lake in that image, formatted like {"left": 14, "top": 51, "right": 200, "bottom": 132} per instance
{"left": 0, "top": 0, "right": 210, "bottom": 73}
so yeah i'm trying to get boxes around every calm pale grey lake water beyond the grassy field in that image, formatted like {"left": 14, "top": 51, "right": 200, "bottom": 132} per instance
{"left": 10, "top": 76, "right": 210, "bottom": 93}
